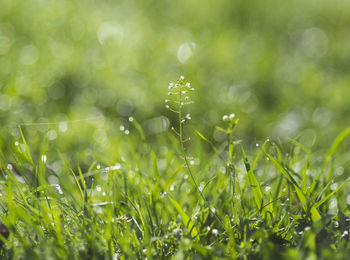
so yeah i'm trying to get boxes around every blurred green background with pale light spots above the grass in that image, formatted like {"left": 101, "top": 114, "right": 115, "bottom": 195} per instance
{"left": 0, "top": 0, "right": 350, "bottom": 165}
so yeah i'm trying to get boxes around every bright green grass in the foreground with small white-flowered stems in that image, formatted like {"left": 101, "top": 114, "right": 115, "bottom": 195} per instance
{"left": 0, "top": 77, "right": 350, "bottom": 259}
